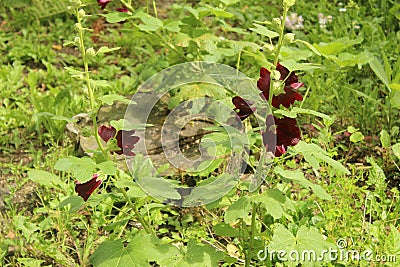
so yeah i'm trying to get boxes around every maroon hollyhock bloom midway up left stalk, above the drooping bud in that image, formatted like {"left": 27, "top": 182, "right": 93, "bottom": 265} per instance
{"left": 98, "top": 125, "right": 139, "bottom": 156}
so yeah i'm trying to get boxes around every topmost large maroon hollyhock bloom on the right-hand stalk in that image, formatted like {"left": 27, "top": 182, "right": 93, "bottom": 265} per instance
{"left": 257, "top": 63, "right": 304, "bottom": 108}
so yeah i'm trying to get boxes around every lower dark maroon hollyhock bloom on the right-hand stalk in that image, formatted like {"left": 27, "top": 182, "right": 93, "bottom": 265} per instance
{"left": 262, "top": 117, "right": 300, "bottom": 157}
